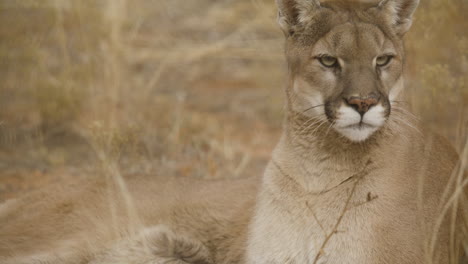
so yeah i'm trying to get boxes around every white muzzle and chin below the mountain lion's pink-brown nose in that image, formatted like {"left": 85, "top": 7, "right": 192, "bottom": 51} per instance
{"left": 333, "top": 105, "right": 386, "bottom": 142}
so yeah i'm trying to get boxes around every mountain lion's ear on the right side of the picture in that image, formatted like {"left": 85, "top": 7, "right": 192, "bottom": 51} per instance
{"left": 377, "top": 0, "right": 419, "bottom": 36}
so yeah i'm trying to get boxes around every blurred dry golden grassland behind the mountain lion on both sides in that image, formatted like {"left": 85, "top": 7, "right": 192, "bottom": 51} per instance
{"left": 0, "top": 0, "right": 468, "bottom": 201}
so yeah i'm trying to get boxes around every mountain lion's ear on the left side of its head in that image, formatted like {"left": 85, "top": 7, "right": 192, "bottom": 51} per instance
{"left": 276, "top": 0, "right": 321, "bottom": 36}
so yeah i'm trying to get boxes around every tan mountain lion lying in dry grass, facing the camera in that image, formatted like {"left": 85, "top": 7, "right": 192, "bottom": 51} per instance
{"left": 0, "top": 0, "right": 466, "bottom": 264}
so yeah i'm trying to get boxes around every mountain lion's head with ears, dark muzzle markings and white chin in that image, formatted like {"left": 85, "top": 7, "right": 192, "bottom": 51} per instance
{"left": 277, "top": 0, "right": 419, "bottom": 142}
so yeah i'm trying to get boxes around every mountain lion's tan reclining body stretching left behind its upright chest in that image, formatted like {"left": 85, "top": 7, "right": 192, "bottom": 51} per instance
{"left": 0, "top": 176, "right": 258, "bottom": 264}
